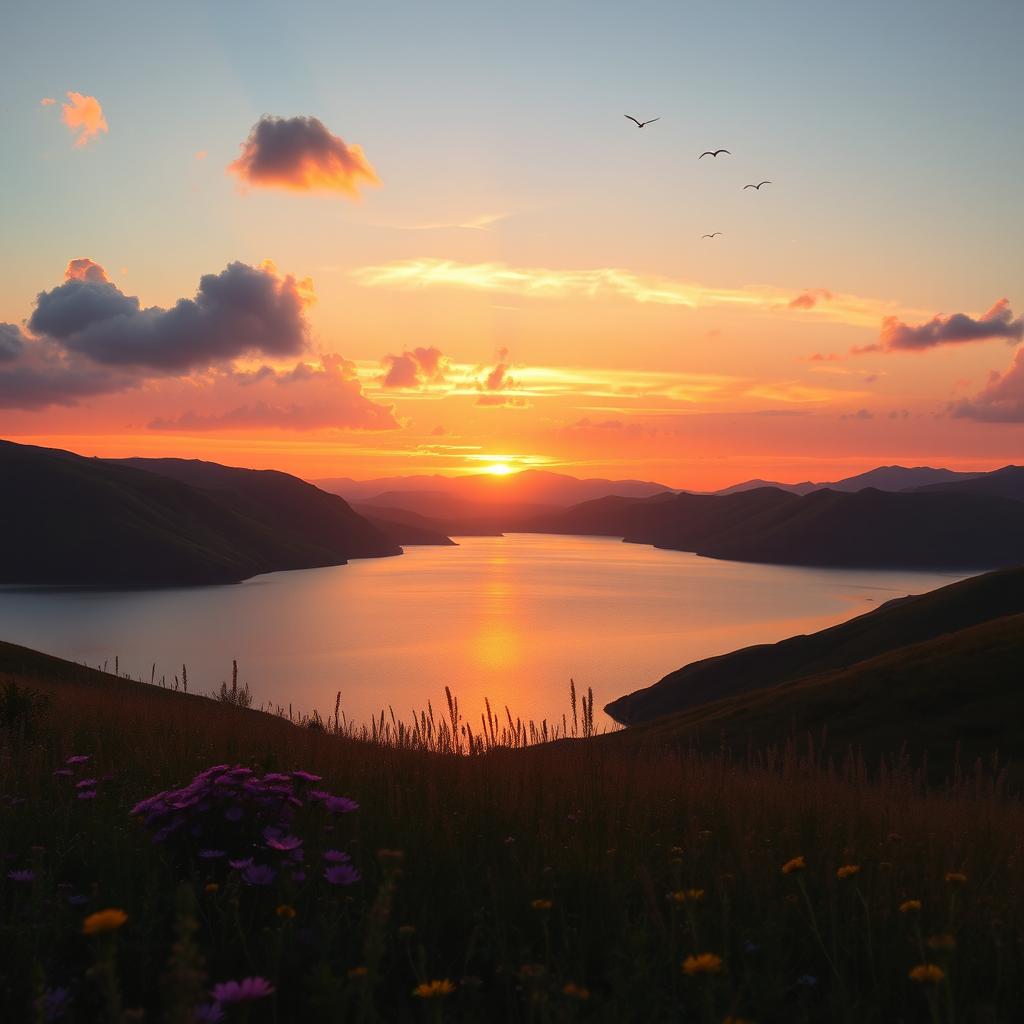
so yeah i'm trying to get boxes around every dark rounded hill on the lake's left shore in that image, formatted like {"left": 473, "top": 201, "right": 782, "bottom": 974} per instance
{"left": 0, "top": 441, "right": 401, "bottom": 585}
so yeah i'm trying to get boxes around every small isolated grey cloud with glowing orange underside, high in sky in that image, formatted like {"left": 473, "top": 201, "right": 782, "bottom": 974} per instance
{"left": 227, "top": 115, "right": 380, "bottom": 199}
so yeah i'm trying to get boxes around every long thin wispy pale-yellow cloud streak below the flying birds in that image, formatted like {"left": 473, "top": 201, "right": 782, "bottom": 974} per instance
{"left": 352, "top": 257, "right": 906, "bottom": 327}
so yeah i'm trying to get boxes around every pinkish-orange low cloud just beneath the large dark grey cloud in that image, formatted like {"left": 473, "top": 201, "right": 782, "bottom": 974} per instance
{"left": 148, "top": 354, "right": 399, "bottom": 433}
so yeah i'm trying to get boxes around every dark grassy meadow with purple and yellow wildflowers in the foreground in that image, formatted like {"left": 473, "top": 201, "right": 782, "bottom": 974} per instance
{"left": 0, "top": 645, "right": 1024, "bottom": 1024}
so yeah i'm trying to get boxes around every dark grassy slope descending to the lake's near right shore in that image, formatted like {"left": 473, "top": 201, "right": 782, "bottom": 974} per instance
{"left": 605, "top": 569, "right": 1024, "bottom": 780}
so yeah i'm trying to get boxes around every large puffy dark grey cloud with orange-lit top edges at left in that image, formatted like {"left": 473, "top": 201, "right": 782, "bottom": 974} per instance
{"left": 29, "top": 260, "right": 312, "bottom": 374}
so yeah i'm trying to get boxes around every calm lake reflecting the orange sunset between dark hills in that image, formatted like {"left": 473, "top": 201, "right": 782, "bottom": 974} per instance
{"left": 0, "top": 535, "right": 961, "bottom": 724}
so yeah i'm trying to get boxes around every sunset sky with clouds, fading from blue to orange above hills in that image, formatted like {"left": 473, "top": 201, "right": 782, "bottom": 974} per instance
{"left": 0, "top": 0, "right": 1024, "bottom": 488}
